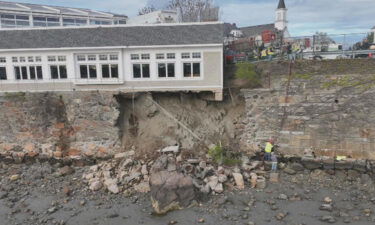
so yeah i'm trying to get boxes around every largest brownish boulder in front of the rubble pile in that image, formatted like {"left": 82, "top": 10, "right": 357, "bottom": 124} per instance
{"left": 150, "top": 171, "right": 195, "bottom": 214}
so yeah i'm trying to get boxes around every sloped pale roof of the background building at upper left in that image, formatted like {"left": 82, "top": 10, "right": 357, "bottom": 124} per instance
{"left": 0, "top": 1, "right": 127, "bottom": 18}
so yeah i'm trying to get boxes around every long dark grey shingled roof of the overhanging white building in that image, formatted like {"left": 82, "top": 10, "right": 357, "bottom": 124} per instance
{"left": 0, "top": 23, "right": 224, "bottom": 50}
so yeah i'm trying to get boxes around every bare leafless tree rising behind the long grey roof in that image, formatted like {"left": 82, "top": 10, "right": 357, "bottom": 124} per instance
{"left": 167, "top": 0, "right": 220, "bottom": 22}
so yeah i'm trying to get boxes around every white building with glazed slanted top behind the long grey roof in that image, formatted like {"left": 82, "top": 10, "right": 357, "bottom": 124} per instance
{"left": 0, "top": 1, "right": 127, "bottom": 29}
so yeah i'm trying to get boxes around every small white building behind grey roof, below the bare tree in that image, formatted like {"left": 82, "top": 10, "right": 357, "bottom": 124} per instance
{"left": 128, "top": 10, "right": 179, "bottom": 24}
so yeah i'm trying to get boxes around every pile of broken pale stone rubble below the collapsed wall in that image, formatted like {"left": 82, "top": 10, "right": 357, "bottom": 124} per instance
{"left": 83, "top": 146, "right": 266, "bottom": 195}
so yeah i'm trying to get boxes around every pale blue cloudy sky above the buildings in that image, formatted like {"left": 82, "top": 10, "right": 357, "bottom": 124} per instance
{"left": 5, "top": 0, "right": 375, "bottom": 36}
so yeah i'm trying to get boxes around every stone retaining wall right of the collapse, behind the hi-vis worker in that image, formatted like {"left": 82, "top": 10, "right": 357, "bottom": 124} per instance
{"left": 241, "top": 60, "right": 375, "bottom": 160}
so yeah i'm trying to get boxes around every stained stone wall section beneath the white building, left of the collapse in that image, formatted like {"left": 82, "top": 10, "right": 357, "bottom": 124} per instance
{"left": 0, "top": 92, "right": 120, "bottom": 161}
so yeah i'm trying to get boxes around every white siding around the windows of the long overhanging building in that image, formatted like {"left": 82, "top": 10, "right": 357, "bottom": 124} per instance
{"left": 0, "top": 45, "right": 223, "bottom": 99}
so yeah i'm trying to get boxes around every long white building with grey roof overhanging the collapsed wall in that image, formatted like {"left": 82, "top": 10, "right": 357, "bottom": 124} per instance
{"left": 0, "top": 23, "right": 223, "bottom": 100}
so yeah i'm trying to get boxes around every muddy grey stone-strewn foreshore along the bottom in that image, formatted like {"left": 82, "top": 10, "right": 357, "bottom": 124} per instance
{"left": 0, "top": 163, "right": 375, "bottom": 225}
